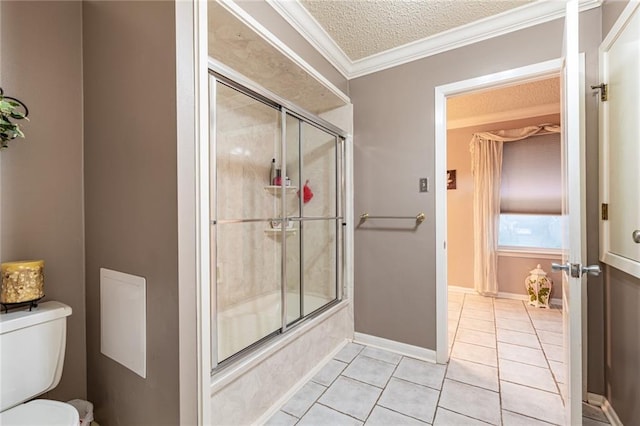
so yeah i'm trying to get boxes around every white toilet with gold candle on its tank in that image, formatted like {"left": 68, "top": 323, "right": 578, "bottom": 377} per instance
{"left": 0, "top": 302, "right": 80, "bottom": 426}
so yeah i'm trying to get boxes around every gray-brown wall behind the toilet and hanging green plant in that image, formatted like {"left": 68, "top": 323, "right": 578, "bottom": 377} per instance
{"left": 0, "top": 1, "right": 86, "bottom": 401}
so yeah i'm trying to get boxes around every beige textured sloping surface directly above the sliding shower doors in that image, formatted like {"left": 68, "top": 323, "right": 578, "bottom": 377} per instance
{"left": 208, "top": 1, "right": 345, "bottom": 114}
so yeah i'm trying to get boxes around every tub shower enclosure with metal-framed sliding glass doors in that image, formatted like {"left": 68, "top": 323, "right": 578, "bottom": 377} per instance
{"left": 209, "top": 71, "right": 345, "bottom": 366}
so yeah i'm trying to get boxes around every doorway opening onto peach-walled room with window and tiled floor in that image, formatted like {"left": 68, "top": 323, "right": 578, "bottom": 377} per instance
{"left": 447, "top": 76, "right": 565, "bottom": 410}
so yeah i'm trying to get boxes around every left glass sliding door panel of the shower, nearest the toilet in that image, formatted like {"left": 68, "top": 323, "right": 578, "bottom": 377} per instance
{"left": 210, "top": 79, "right": 282, "bottom": 363}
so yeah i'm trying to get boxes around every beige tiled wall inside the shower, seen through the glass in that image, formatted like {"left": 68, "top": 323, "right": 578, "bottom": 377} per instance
{"left": 211, "top": 85, "right": 341, "bottom": 310}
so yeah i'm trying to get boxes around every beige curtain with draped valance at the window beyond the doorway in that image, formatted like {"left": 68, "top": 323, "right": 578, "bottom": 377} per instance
{"left": 470, "top": 124, "right": 560, "bottom": 296}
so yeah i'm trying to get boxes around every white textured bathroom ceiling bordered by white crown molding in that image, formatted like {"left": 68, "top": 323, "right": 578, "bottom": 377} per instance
{"left": 299, "top": 0, "right": 534, "bottom": 61}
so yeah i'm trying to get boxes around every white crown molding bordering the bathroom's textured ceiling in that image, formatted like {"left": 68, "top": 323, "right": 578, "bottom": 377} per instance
{"left": 266, "top": 0, "right": 602, "bottom": 79}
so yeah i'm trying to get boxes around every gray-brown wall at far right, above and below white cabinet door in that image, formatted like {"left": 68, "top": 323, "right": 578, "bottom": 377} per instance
{"left": 602, "top": 0, "right": 640, "bottom": 425}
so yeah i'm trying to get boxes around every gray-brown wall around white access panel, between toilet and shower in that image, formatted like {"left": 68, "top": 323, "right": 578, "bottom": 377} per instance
{"left": 83, "top": 1, "right": 180, "bottom": 426}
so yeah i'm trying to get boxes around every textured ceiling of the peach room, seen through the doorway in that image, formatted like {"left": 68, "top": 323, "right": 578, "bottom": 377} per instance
{"left": 447, "top": 77, "right": 560, "bottom": 120}
